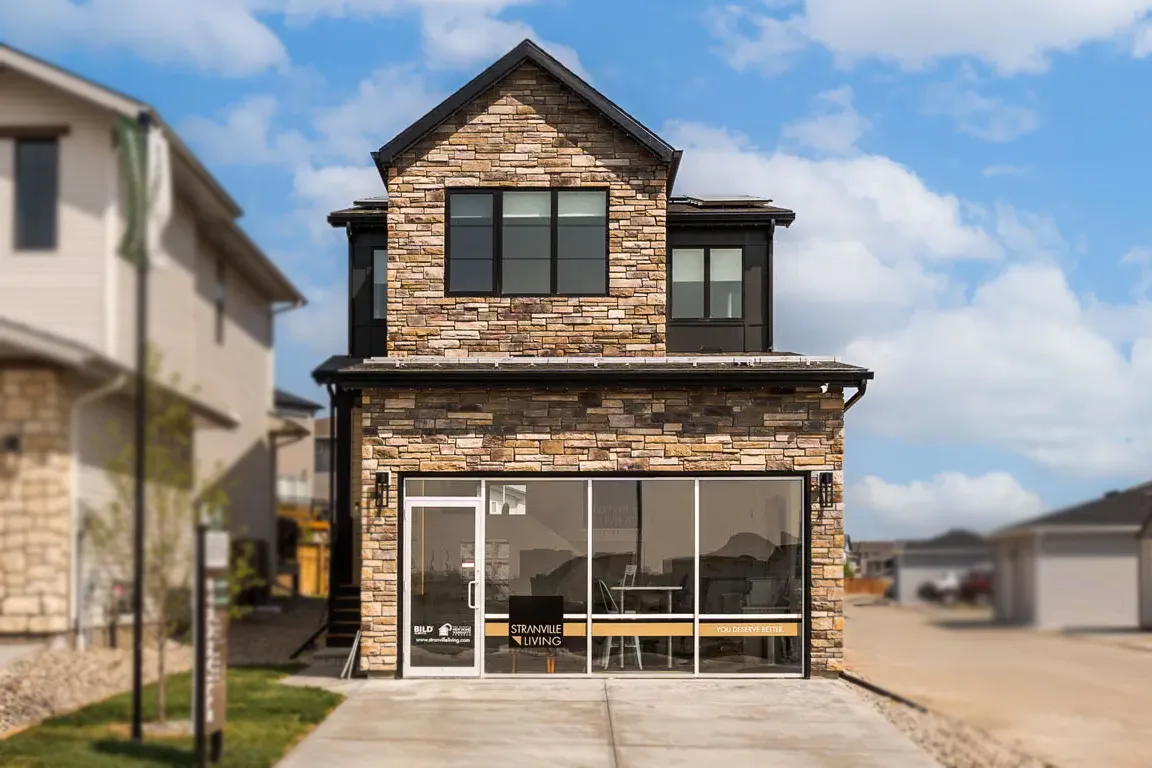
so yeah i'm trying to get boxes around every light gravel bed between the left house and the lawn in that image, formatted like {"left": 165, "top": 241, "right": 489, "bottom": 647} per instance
{"left": 0, "top": 644, "right": 192, "bottom": 737}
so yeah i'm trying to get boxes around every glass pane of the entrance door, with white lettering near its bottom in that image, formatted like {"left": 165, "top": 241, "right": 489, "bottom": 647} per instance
{"left": 408, "top": 507, "right": 476, "bottom": 667}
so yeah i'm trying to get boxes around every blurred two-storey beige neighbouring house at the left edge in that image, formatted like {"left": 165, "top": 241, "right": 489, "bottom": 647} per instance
{"left": 0, "top": 45, "right": 304, "bottom": 634}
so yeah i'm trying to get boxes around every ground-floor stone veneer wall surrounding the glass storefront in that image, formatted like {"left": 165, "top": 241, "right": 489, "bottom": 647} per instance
{"left": 361, "top": 389, "right": 843, "bottom": 675}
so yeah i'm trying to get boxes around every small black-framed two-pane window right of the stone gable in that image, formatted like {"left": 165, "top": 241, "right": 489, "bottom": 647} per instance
{"left": 669, "top": 248, "right": 744, "bottom": 320}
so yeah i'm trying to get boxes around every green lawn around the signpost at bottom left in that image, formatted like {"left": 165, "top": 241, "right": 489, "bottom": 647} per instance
{"left": 0, "top": 667, "right": 343, "bottom": 768}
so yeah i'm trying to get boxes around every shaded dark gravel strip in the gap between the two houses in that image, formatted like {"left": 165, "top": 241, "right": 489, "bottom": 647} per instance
{"left": 228, "top": 598, "right": 326, "bottom": 664}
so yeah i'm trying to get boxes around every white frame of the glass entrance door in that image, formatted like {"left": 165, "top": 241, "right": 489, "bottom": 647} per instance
{"left": 400, "top": 494, "right": 485, "bottom": 677}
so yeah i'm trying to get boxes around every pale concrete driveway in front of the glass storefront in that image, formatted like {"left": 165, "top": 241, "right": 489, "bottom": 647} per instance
{"left": 280, "top": 678, "right": 939, "bottom": 768}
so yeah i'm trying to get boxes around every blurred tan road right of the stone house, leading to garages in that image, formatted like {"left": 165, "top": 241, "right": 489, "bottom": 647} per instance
{"left": 844, "top": 604, "right": 1152, "bottom": 768}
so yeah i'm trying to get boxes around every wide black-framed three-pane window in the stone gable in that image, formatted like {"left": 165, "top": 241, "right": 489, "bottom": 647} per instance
{"left": 446, "top": 189, "right": 608, "bottom": 296}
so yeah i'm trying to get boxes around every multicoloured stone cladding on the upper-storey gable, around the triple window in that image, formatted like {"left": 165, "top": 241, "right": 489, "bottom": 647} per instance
{"left": 387, "top": 63, "right": 668, "bottom": 357}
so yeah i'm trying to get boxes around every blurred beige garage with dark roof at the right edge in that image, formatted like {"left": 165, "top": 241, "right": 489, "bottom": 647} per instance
{"left": 992, "top": 482, "right": 1152, "bottom": 629}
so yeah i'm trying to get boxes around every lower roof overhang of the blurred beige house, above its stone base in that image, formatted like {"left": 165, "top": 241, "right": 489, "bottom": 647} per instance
{"left": 0, "top": 318, "right": 240, "bottom": 429}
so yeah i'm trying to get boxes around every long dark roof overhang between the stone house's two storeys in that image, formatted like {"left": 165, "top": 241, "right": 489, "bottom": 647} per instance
{"left": 312, "top": 355, "right": 874, "bottom": 389}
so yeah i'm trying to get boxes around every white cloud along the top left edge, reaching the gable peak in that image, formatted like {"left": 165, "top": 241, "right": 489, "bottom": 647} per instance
{"left": 0, "top": 0, "right": 583, "bottom": 76}
